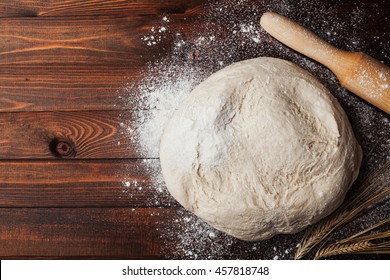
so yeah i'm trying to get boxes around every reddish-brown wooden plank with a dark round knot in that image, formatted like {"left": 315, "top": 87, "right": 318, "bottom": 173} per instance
{"left": 0, "top": 111, "right": 143, "bottom": 159}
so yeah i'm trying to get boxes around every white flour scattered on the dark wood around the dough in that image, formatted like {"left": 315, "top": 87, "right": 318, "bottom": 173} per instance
{"left": 121, "top": 0, "right": 390, "bottom": 259}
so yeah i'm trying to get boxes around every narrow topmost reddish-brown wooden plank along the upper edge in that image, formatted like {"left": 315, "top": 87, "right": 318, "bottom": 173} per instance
{"left": 0, "top": 0, "right": 390, "bottom": 24}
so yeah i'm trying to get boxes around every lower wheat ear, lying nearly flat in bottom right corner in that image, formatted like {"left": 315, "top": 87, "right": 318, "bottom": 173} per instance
{"left": 314, "top": 218, "right": 390, "bottom": 259}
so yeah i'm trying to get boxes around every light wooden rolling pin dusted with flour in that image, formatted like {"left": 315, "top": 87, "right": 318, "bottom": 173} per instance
{"left": 260, "top": 12, "right": 390, "bottom": 114}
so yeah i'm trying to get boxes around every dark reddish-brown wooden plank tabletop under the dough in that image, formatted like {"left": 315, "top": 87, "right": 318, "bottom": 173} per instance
{"left": 0, "top": 0, "right": 390, "bottom": 259}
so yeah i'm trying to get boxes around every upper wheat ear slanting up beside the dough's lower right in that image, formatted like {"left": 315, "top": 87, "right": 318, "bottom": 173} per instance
{"left": 294, "top": 162, "right": 390, "bottom": 259}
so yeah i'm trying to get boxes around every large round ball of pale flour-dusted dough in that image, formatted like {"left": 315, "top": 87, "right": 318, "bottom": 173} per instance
{"left": 160, "top": 58, "right": 362, "bottom": 240}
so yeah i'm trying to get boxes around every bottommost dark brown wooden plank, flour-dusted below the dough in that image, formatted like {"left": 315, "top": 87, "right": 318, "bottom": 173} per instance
{"left": 0, "top": 203, "right": 389, "bottom": 260}
